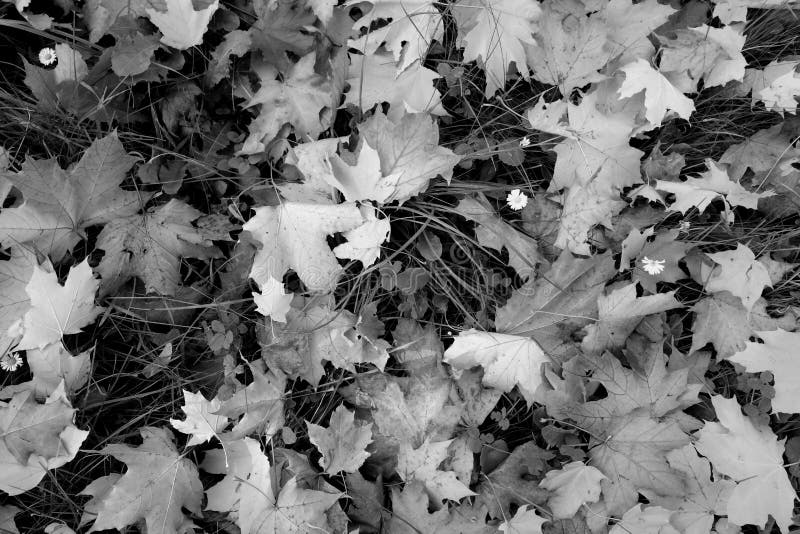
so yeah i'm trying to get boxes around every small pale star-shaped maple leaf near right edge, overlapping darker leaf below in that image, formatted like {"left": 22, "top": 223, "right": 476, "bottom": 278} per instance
{"left": 706, "top": 243, "right": 772, "bottom": 311}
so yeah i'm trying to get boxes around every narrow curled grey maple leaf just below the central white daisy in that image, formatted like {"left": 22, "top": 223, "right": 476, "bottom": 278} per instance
{"left": 455, "top": 194, "right": 544, "bottom": 281}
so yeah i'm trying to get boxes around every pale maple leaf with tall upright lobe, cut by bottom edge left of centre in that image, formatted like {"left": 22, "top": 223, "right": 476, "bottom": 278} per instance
{"left": 236, "top": 442, "right": 340, "bottom": 534}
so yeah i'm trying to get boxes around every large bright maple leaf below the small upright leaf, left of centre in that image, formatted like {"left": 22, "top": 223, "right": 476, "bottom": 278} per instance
{"left": 242, "top": 202, "right": 363, "bottom": 291}
